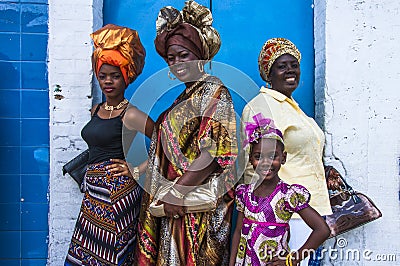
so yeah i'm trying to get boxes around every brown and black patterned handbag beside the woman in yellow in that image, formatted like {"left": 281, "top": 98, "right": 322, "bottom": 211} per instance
{"left": 325, "top": 166, "right": 382, "bottom": 238}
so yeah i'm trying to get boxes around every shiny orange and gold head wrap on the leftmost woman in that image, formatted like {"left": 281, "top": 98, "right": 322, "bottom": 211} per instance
{"left": 90, "top": 24, "right": 146, "bottom": 86}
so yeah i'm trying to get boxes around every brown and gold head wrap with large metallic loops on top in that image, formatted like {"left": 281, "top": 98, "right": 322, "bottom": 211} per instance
{"left": 154, "top": 1, "right": 221, "bottom": 60}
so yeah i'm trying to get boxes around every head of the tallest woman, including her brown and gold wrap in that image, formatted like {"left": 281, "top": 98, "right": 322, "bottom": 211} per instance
{"left": 154, "top": 1, "right": 221, "bottom": 84}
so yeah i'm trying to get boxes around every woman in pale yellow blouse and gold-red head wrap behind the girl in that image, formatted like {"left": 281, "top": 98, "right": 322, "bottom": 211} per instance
{"left": 241, "top": 38, "right": 331, "bottom": 265}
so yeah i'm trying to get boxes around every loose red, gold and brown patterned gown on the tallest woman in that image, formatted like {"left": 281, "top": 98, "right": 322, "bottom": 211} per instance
{"left": 135, "top": 76, "right": 237, "bottom": 266}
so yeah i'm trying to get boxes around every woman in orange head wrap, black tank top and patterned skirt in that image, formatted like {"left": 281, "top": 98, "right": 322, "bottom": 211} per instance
{"left": 65, "top": 24, "right": 154, "bottom": 265}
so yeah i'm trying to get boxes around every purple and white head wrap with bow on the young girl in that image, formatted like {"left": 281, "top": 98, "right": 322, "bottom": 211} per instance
{"left": 243, "top": 113, "right": 284, "bottom": 150}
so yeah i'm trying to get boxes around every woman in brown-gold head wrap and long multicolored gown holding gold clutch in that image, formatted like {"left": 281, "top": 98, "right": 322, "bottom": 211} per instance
{"left": 136, "top": 1, "right": 237, "bottom": 265}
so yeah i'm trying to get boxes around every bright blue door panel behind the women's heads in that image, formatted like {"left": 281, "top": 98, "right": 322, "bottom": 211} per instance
{"left": 103, "top": 0, "right": 314, "bottom": 118}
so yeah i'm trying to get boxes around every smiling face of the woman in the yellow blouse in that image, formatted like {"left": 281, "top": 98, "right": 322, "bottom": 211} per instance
{"left": 268, "top": 54, "right": 300, "bottom": 98}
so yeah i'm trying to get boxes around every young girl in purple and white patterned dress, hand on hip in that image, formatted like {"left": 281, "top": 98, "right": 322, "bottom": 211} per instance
{"left": 230, "top": 113, "right": 330, "bottom": 266}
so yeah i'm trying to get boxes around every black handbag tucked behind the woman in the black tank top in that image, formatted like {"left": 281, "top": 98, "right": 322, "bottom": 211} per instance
{"left": 62, "top": 149, "right": 89, "bottom": 192}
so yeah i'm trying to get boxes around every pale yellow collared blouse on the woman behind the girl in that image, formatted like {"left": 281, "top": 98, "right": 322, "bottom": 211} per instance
{"left": 241, "top": 87, "right": 332, "bottom": 218}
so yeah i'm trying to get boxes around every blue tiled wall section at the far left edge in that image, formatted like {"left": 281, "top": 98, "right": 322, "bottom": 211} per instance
{"left": 0, "top": 0, "right": 49, "bottom": 266}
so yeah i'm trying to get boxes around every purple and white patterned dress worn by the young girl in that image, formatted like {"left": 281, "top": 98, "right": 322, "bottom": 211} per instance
{"left": 235, "top": 181, "right": 310, "bottom": 266}
